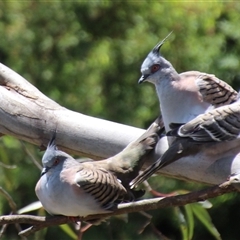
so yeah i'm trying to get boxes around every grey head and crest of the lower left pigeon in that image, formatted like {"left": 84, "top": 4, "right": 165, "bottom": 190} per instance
{"left": 41, "top": 132, "right": 71, "bottom": 175}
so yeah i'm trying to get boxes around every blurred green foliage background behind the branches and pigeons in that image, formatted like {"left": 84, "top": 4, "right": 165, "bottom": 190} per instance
{"left": 0, "top": 1, "right": 240, "bottom": 239}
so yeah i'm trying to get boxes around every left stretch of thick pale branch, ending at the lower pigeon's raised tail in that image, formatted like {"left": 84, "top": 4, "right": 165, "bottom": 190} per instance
{"left": 0, "top": 64, "right": 150, "bottom": 159}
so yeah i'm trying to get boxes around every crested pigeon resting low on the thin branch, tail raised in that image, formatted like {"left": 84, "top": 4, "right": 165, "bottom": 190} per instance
{"left": 35, "top": 118, "right": 163, "bottom": 217}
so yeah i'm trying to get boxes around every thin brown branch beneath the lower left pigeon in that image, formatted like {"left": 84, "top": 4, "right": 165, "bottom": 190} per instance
{"left": 0, "top": 181, "right": 237, "bottom": 237}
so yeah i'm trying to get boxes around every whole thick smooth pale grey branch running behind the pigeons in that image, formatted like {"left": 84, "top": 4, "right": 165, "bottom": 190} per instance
{"left": 0, "top": 64, "right": 240, "bottom": 184}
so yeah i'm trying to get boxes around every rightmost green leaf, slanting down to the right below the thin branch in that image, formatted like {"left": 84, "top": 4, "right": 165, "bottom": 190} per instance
{"left": 191, "top": 203, "right": 221, "bottom": 240}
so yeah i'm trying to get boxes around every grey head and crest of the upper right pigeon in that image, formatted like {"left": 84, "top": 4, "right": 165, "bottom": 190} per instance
{"left": 138, "top": 32, "right": 173, "bottom": 84}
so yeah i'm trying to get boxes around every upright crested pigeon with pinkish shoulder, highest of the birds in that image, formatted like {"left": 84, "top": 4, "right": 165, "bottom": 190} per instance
{"left": 138, "top": 32, "right": 238, "bottom": 131}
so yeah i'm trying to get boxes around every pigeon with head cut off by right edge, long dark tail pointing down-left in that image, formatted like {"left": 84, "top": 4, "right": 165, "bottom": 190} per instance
{"left": 130, "top": 99, "right": 240, "bottom": 188}
